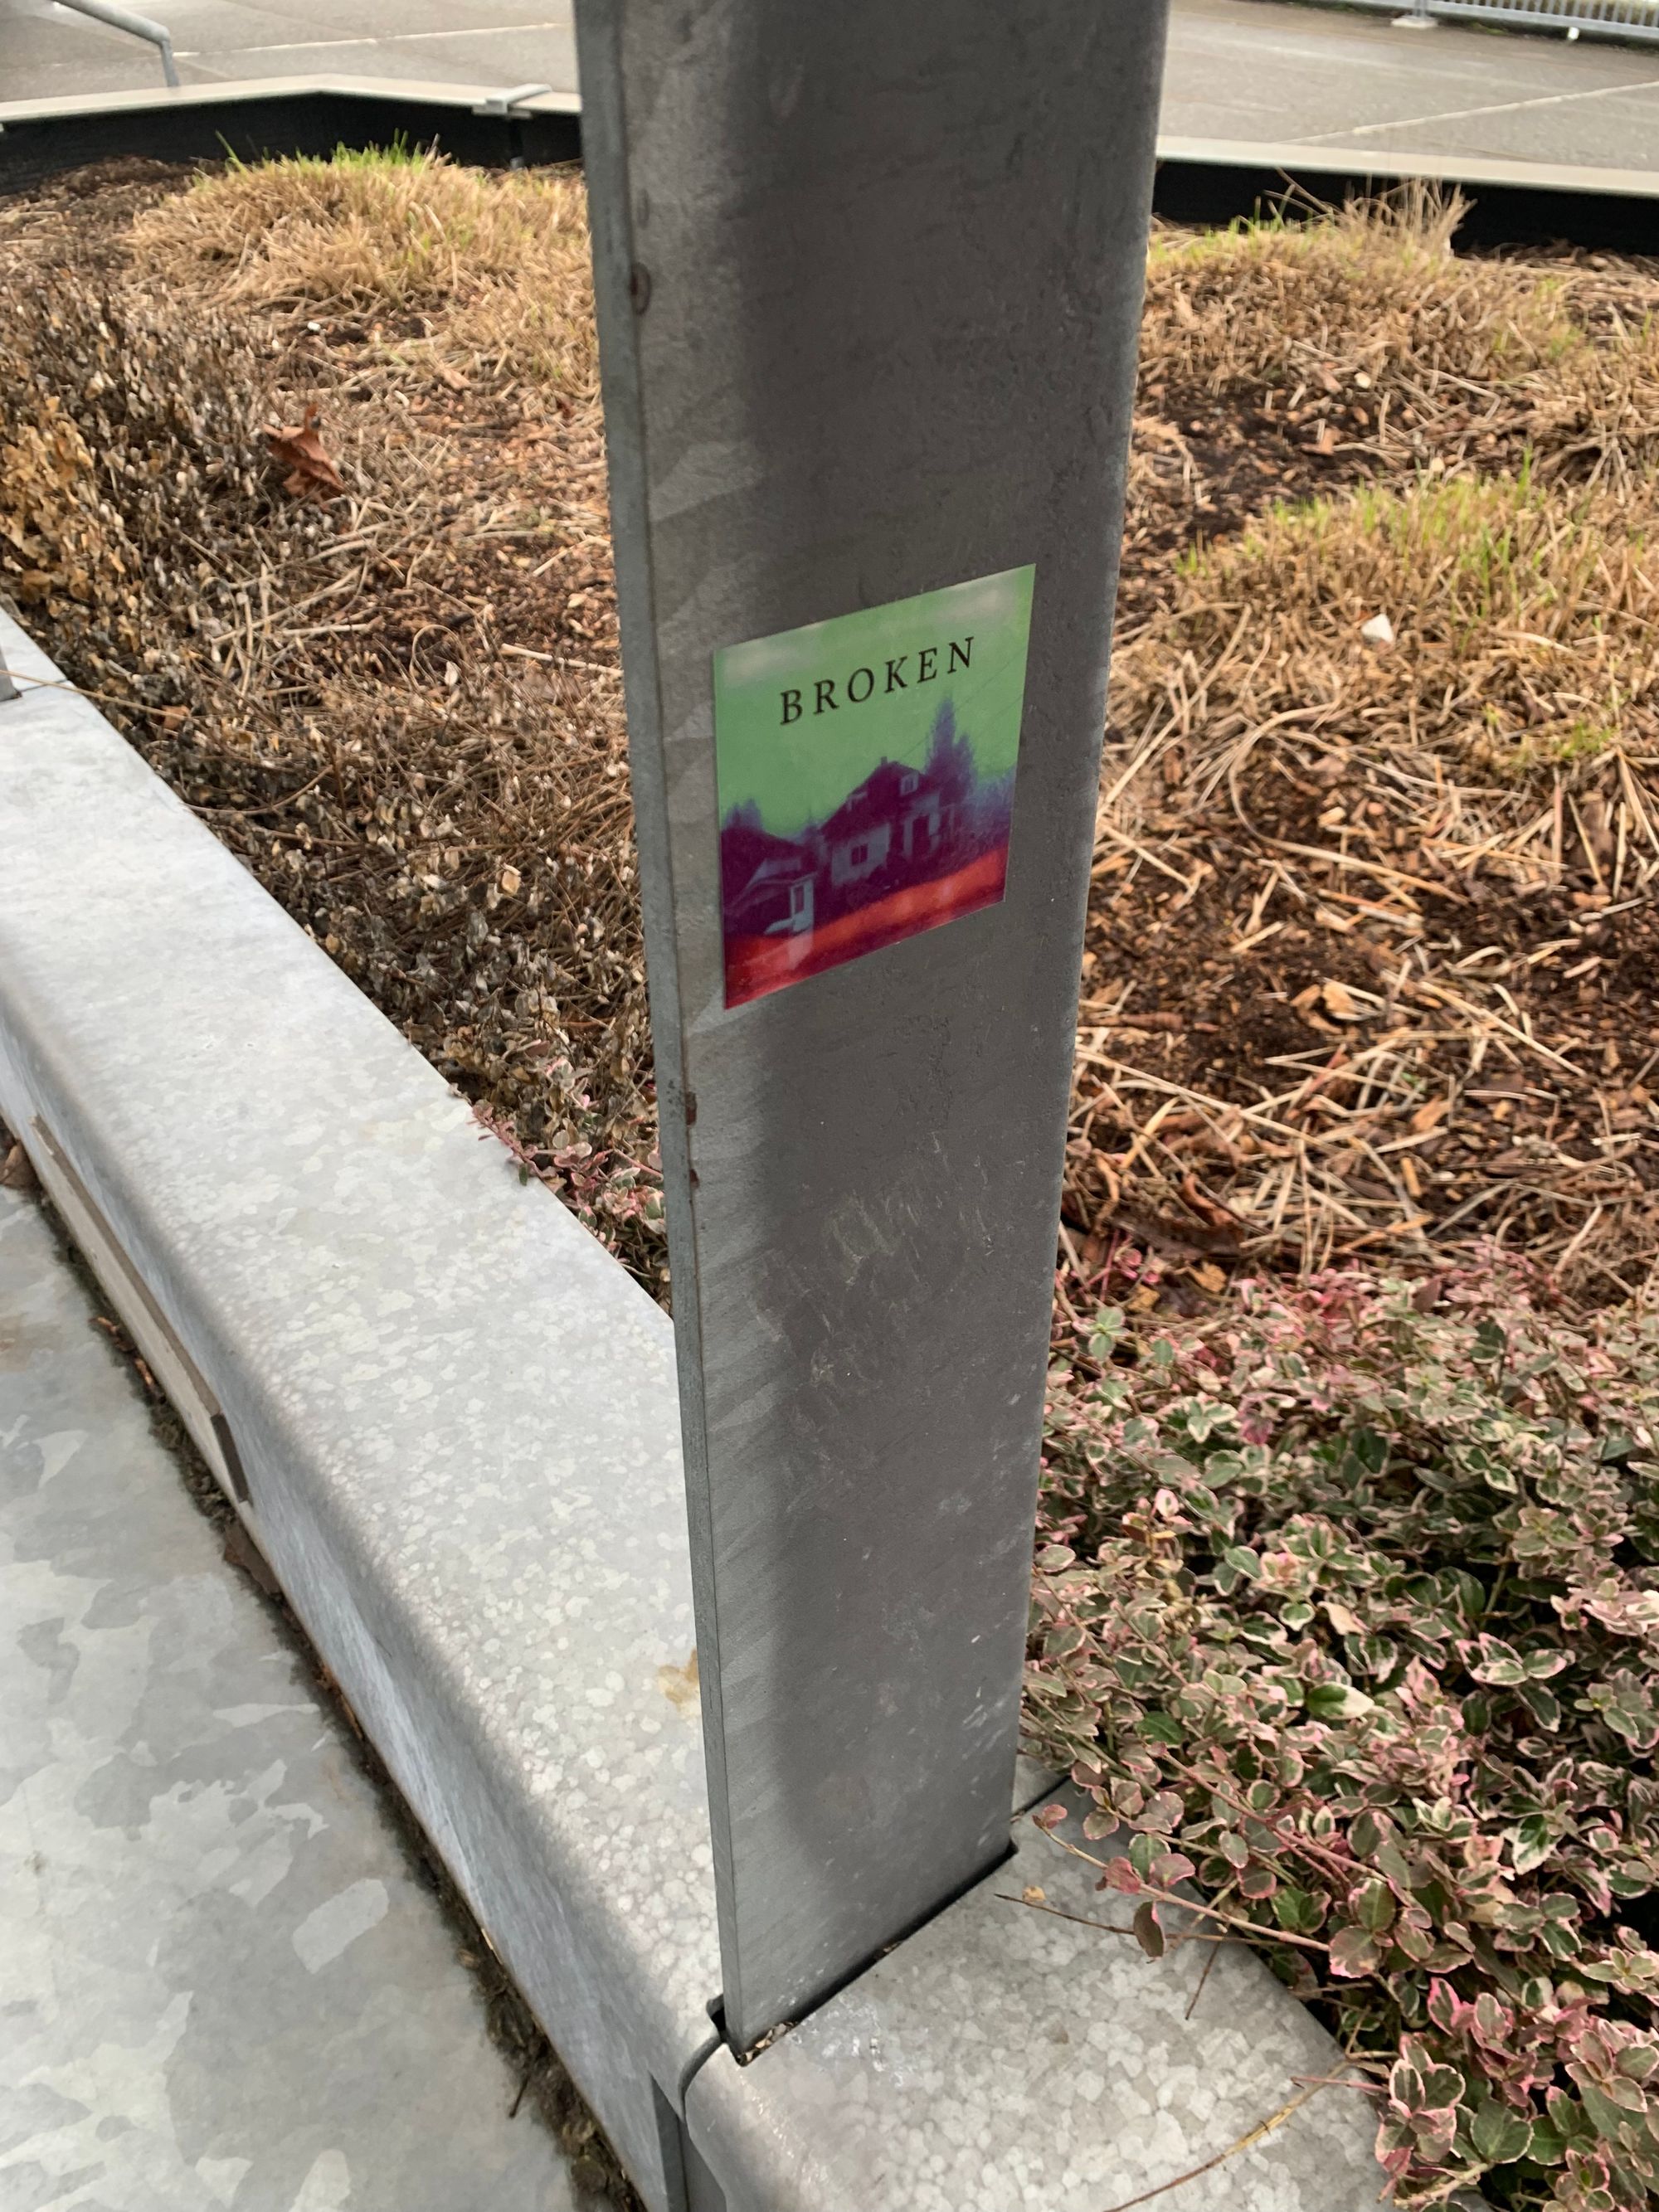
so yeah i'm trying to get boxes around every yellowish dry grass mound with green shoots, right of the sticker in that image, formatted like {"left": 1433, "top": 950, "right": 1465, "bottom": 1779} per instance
{"left": 1115, "top": 475, "right": 1659, "bottom": 863}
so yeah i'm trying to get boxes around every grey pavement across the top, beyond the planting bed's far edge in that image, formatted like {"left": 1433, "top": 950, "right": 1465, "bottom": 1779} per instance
{"left": 0, "top": 0, "right": 1659, "bottom": 170}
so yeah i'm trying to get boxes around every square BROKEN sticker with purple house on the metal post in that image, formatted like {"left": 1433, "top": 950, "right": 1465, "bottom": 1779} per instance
{"left": 714, "top": 568, "right": 1035, "bottom": 1006}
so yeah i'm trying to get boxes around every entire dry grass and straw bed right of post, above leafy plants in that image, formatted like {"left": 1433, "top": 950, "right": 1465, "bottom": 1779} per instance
{"left": 1044, "top": 195, "right": 1659, "bottom": 1305}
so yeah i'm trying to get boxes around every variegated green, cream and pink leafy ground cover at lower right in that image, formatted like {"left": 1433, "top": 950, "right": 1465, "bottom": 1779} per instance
{"left": 1029, "top": 1257, "right": 1659, "bottom": 2212}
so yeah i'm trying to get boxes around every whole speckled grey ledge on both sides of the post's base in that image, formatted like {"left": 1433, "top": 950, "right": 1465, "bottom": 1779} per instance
{"left": 0, "top": 617, "right": 1378, "bottom": 2212}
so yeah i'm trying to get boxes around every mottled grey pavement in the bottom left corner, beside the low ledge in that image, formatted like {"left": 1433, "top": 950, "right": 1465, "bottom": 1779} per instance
{"left": 0, "top": 1185, "right": 577, "bottom": 2212}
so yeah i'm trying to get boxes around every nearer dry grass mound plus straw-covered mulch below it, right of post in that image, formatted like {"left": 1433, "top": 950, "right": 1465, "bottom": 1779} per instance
{"left": 1073, "top": 459, "right": 1659, "bottom": 1296}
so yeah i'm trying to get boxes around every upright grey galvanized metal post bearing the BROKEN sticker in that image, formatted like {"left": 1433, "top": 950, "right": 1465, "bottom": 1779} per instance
{"left": 577, "top": 0, "right": 1165, "bottom": 2050}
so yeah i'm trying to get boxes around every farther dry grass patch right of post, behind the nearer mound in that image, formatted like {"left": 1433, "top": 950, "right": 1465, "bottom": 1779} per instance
{"left": 1121, "top": 190, "right": 1659, "bottom": 621}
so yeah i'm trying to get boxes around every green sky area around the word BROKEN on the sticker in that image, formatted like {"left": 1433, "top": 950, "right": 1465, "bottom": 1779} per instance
{"left": 714, "top": 568, "right": 1035, "bottom": 836}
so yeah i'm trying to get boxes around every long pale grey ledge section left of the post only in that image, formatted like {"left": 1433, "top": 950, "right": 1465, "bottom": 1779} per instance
{"left": 0, "top": 617, "right": 719, "bottom": 2208}
